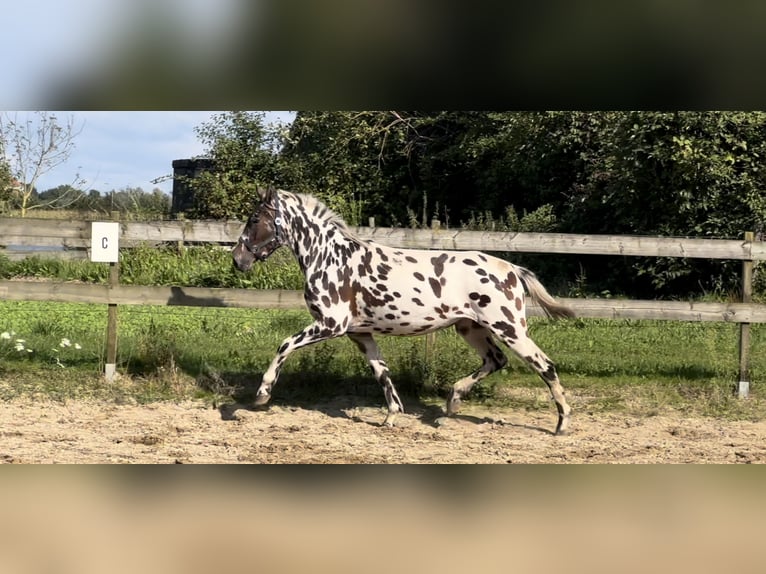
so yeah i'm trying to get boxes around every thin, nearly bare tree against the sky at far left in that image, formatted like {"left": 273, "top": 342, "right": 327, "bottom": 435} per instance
{"left": 0, "top": 112, "right": 83, "bottom": 217}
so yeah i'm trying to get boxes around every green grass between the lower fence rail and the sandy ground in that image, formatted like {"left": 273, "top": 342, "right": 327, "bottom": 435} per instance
{"left": 0, "top": 301, "right": 766, "bottom": 419}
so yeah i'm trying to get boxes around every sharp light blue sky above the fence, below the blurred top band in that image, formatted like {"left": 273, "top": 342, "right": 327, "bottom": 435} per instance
{"left": 19, "top": 111, "right": 295, "bottom": 197}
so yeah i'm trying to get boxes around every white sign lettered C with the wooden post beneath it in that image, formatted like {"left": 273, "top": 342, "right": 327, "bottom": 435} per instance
{"left": 90, "top": 221, "right": 120, "bottom": 381}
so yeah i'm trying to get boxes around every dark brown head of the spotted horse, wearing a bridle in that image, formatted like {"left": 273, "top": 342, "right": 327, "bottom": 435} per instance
{"left": 231, "top": 188, "right": 283, "bottom": 271}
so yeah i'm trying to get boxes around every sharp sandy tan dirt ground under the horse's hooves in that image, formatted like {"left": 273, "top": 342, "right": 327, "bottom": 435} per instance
{"left": 0, "top": 397, "right": 766, "bottom": 463}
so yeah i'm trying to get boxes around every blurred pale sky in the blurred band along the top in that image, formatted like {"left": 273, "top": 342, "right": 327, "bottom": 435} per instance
{"left": 0, "top": 0, "right": 247, "bottom": 109}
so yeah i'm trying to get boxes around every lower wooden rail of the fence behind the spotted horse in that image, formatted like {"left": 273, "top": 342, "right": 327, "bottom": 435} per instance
{"left": 0, "top": 281, "right": 766, "bottom": 323}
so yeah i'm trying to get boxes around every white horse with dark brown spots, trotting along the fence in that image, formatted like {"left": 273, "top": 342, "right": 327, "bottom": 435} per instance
{"left": 232, "top": 189, "right": 574, "bottom": 434}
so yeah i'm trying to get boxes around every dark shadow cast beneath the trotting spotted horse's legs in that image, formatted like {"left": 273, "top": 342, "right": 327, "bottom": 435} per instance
{"left": 210, "top": 373, "right": 554, "bottom": 434}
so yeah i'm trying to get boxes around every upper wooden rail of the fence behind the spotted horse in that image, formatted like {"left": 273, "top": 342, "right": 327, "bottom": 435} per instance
{"left": 0, "top": 218, "right": 766, "bottom": 261}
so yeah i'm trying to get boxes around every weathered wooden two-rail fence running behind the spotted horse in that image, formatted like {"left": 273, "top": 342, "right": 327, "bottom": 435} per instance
{"left": 0, "top": 218, "right": 766, "bottom": 396}
